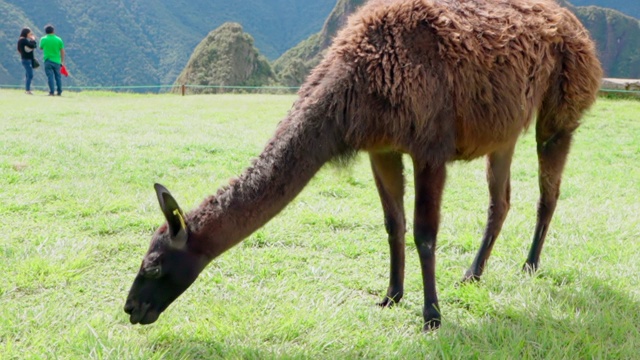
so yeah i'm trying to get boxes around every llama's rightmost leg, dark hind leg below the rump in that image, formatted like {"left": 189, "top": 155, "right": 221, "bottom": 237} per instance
{"left": 523, "top": 121, "right": 577, "bottom": 272}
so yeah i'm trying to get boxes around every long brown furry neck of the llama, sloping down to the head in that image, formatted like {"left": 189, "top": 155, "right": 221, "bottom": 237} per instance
{"left": 188, "top": 103, "right": 345, "bottom": 259}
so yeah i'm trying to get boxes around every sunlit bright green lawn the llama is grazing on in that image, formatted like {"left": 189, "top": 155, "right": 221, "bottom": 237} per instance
{"left": 0, "top": 90, "right": 640, "bottom": 359}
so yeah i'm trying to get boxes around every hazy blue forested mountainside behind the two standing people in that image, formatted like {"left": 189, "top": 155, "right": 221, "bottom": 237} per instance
{"left": 0, "top": 0, "right": 335, "bottom": 86}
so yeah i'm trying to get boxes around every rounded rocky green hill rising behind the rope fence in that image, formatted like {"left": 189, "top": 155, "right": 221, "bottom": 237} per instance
{"left": 174, "top": 23, "right": 274, "bottom": 93}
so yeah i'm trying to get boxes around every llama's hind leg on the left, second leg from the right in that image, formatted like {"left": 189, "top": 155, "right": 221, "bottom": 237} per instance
{"left": 462, "top": 142, "right": 515, "bottom": 282}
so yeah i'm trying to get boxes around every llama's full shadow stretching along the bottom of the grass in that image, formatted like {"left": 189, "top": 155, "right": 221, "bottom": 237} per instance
{"left": 142, "top": 272, "right": 640, "bottom": 359}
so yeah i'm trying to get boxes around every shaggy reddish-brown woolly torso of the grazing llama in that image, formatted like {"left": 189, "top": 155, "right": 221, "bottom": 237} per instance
{"left": 301, "top": 0, "right": 601, "bottom": 162}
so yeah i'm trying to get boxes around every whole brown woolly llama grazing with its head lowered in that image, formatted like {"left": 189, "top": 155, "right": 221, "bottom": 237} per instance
{"left": 125, "top": 0, "right": 602, "bottom": 329}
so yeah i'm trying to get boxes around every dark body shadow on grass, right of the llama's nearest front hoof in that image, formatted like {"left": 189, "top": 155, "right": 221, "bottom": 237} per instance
{"left": 438, "top": 272, "right": 640, "bottom": 359}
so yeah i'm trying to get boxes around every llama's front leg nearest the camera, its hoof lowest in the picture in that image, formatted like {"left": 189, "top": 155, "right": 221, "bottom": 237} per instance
{"left": 414, "top": 162, "right": 446, "bottom": 330}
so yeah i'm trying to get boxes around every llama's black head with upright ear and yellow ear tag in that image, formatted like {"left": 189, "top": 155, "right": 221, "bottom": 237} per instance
{"left": 124, "top": 184, "right": 206, "bottom": 324}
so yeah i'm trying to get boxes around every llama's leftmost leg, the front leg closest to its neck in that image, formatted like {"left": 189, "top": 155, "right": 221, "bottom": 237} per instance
{"left": 369, "top": 152, "right": 406, "bottom": 307}
